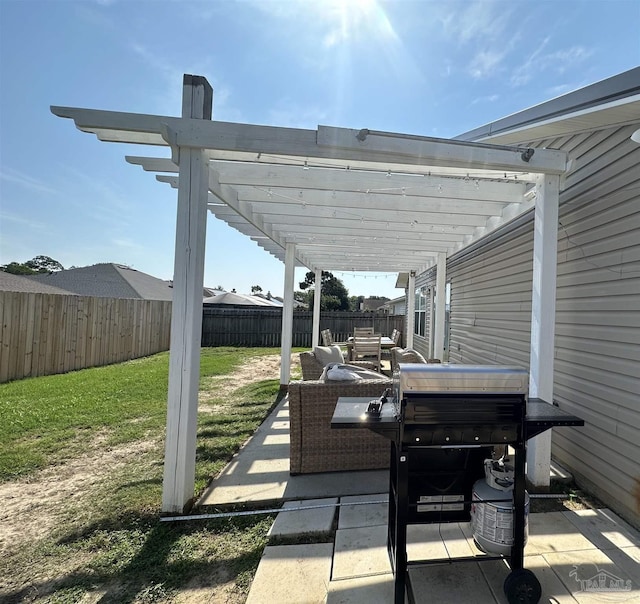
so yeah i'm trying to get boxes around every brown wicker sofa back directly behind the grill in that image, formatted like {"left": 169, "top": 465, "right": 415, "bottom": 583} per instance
{"left": 289, "top": 376, "right": 392, "bottom": 474}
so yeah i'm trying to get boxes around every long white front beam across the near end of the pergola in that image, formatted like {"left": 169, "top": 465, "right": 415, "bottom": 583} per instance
{"left": 51, "top": 106, "right": 567, "bottom": 174}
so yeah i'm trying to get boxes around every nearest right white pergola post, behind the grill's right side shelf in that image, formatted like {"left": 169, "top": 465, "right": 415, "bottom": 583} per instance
{"left": 527, "top": 175, "right": 560, "bottom": 486}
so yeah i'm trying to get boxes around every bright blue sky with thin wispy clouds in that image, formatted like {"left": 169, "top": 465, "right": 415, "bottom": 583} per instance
{"left": 0, "top": 0, "right": 640, "bottom": 298}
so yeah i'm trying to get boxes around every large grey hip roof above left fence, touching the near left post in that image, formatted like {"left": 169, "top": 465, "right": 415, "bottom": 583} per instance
{"left": 27, "top": 263, "right": 173, "bottom": 300}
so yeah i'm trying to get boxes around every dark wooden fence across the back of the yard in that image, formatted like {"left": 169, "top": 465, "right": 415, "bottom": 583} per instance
{"left": 202, "top": 305, "right": 404, "bottom": 348}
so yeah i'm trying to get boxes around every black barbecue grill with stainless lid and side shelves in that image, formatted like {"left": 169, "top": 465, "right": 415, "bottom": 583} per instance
{"left": 331, "top": 364, "right": 584, "bottom": 604}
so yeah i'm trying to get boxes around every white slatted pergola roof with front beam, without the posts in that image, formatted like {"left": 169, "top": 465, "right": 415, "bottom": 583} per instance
{"left": 52, "top": 101, "right": 567, "bottom": 273}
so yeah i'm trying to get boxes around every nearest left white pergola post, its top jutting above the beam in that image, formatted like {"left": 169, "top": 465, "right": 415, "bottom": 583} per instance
{"left": 162, "top": 75, "right": 212, "bottom": 513}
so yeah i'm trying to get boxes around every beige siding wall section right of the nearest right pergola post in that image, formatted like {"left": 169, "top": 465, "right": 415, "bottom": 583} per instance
{"left": 553, "top": 128, "right": 640, "bottom": 524}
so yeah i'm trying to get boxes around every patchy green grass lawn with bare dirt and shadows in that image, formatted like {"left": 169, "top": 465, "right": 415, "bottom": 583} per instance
{"left": 0, "top": 348, "right": 296, "bottom": 604}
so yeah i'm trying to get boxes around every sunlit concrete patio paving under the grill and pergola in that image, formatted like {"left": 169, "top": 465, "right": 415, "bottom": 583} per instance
{"left": 197, "top": 399, "right": 640, "bottom": 604}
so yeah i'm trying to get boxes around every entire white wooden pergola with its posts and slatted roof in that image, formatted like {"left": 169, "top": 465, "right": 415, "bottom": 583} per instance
{"left": 51, "top": 75, "right": 567, "bottom": 513}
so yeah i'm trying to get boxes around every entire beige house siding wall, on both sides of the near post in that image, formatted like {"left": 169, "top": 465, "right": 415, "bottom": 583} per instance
{"left": 440, "top": 126, "right": 640, "bottom": 524}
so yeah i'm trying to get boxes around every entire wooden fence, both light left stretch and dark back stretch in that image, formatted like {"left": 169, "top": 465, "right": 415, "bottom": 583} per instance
{"left": 0, "top": 291, "right": 404, "bottom": 382}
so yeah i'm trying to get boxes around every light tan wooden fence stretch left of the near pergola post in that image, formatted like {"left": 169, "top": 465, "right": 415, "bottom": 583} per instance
{"left": 0, "top": 291, "right": 171, "bottom": 382}
